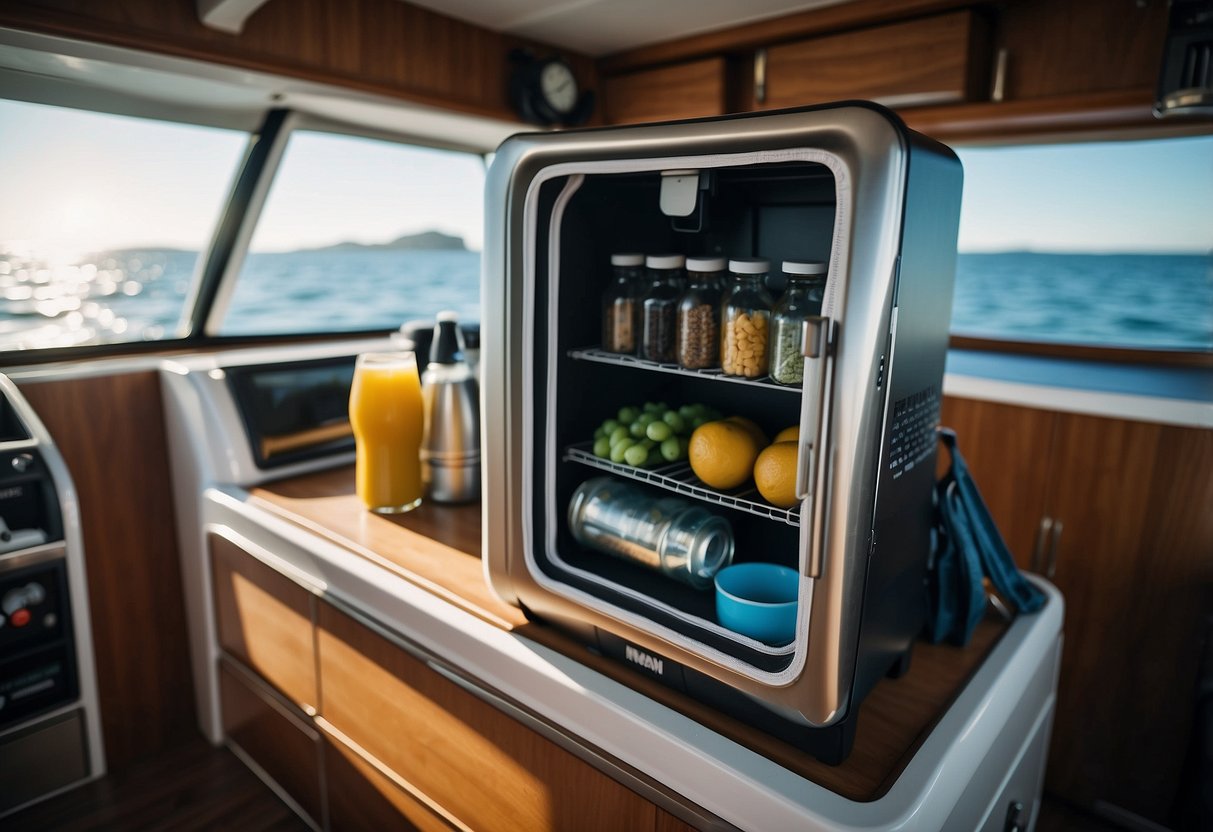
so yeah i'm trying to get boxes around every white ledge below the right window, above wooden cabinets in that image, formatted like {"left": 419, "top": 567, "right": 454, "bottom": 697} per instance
{"left": 944, "top": 372, "right": 1213, "bottom": 428}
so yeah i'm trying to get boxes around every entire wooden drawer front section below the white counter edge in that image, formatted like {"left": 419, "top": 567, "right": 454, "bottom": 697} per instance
{"left": 210, "top": 535, "right": 685, "bottom": 832}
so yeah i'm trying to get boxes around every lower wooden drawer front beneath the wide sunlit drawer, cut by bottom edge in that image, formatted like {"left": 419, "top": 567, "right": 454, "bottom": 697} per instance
{"left": 318, "top": 719, "right": 463, "bottom": 832}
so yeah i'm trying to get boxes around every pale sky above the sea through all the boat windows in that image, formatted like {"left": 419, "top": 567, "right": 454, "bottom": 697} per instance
{"left": 0, "top": 101, "right": 1213, "bottom": 257}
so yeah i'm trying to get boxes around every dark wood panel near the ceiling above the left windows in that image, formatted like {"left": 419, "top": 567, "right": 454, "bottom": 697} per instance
{"left": 0, "top": 0, "right": 597, "bottom": 119}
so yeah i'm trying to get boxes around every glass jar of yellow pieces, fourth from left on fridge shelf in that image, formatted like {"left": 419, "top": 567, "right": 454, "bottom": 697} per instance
{"left": 721, "top": 257, "right": 771, "bottom": 378}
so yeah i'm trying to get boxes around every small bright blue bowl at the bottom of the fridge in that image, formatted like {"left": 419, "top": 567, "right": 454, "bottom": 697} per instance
{"left": 716, "top": 563, "right": 801, "bottom": 644}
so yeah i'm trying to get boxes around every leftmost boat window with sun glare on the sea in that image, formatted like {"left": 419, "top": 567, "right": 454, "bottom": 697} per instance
{"left": 0, "top": 99, "right": 249, "bottom": 349}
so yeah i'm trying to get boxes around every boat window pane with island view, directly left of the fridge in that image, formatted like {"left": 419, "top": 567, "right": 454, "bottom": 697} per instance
{"left": 218, "top": 130, "right": 485, "bottom": 335}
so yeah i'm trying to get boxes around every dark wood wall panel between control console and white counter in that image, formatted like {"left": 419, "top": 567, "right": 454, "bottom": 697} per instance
{"left": 21, "top": 372, "right": 198, "bottom": 770}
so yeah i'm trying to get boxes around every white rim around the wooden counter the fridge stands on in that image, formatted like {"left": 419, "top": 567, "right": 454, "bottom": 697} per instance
{"left": 203, "top": 486, "right": 1061, "bottom": 830}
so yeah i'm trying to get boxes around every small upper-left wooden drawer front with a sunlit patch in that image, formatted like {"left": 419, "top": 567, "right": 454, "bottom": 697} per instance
{"left": 210, "top": 535, "right": 319, "bottom": 713}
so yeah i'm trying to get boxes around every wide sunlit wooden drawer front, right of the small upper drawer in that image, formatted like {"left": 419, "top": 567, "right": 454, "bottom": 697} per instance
{"left": 318, "top": 603, "right": 656, "bottom": 831}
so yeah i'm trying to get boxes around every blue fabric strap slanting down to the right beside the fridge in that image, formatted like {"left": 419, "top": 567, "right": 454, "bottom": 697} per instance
{"left": 938, "top": 428, "right": 1044, "bottom": 612}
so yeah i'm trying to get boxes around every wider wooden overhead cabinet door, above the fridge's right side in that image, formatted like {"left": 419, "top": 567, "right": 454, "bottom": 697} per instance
{"left": 759, "top": 11, "right": 987, "bottom": 108}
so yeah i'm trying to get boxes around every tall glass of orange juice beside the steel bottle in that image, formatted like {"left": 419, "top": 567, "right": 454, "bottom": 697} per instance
{"left": 349, "top": 352, "right": 425, "bottom": 514}
